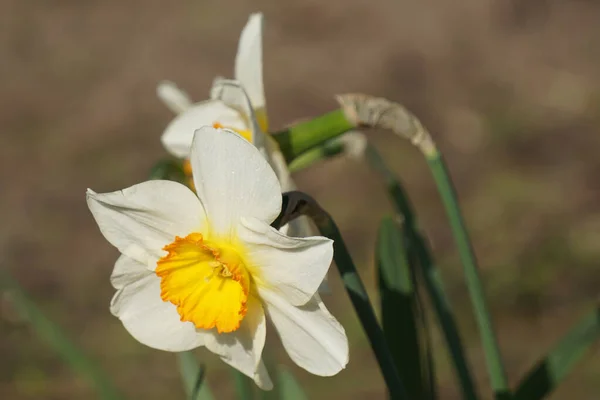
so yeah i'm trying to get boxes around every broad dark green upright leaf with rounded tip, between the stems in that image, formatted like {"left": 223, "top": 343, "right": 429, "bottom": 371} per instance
{"left": 376, "top": 217, "right": 434, "bottom": 400}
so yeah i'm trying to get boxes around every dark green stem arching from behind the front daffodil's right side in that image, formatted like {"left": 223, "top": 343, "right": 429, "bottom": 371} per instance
{"left": 273, "top": 192, "right": 408, "bottom": 400}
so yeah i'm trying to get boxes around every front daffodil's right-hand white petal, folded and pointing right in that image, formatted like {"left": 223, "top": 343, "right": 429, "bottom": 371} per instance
{"left": 238, "top": 218, "right": 333, "bottom": 305}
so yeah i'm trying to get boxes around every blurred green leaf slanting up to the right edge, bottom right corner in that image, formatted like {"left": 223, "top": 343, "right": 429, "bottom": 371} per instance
{"left": 513, "top": 307, "right": 600, "bottom": 400}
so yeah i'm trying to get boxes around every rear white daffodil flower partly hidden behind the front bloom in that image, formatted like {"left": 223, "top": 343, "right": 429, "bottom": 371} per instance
{"left": 157, "top": 13, "right": 315, "bottom": 237}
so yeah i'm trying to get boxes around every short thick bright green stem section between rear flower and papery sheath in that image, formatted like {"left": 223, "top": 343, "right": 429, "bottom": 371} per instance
{"left": 273, "top": 110, "right": 355, "bottom": 163}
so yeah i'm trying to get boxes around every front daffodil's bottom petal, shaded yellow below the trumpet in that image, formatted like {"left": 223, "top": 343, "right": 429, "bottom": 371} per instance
{"left": 205, "top": 296, "right": 273, "bottom": 390}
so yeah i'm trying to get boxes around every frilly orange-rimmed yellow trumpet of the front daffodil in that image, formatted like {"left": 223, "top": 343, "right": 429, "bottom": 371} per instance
{"left": 156, "top": 233, "right": 250, "bottom": 333}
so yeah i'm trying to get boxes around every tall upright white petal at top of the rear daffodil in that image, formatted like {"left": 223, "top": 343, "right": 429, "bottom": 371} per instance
{"left": 235, "top": 13, "right": 265, "bottom": 108}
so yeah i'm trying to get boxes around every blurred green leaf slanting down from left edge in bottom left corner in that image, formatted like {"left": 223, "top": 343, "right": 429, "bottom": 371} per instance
{"left": 0, "top": 269, "right": 124, "bottom": 400}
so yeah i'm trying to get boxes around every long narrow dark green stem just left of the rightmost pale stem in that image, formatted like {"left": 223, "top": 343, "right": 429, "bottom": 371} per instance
{"left": 365, "top": 144, "right": 477, "bottom": 400}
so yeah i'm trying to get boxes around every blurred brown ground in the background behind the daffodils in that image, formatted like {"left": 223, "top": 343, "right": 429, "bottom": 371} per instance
{"left": 0, "top": 0, "right": 600, "bottom": 399}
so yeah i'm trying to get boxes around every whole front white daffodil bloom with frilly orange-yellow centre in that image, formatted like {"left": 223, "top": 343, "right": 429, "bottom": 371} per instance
{"left": 87, "top": 127, "right": 348, "bottom": 389}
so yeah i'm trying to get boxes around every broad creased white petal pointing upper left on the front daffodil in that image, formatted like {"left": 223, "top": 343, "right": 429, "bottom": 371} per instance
{"left": 86, "top": 181, "right": 206, "bottom": 270}
